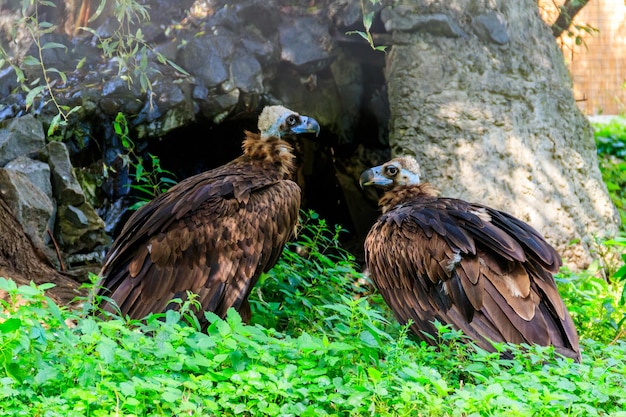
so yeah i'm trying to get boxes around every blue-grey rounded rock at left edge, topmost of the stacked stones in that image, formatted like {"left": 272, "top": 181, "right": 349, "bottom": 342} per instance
{"left": 0, "top": 114, "right": 46, "bottom": 166}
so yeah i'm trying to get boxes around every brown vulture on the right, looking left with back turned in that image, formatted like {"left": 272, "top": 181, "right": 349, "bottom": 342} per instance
{"left": 360, "top": 157, "right": 580, "bottom": 361}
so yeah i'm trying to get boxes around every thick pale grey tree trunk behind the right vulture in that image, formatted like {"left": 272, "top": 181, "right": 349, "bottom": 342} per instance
{"left": 383, "top": 0, "right": 619, "bottom": 267}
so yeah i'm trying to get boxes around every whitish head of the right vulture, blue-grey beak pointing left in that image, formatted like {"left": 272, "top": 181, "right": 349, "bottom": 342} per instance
{"left": 359, "top": 156, "right": 420, "bottom": 190}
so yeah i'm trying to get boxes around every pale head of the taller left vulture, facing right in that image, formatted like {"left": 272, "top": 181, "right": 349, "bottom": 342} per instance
{"left": 258, "top": 106, "right": 320, "bottom": 138}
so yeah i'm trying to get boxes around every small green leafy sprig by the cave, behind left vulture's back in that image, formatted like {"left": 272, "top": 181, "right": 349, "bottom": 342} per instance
{"left": 105, "top": 113, "right": 176, "bottom": 210}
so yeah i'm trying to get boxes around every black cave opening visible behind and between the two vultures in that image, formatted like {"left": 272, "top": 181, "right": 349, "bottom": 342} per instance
{"left": 139, "top": 102, "right": 389, "bottom": 261}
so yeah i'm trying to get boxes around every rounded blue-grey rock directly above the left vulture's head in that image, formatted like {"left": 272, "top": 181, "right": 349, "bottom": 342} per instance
{"left": 278, "top": 16, "right": 335, "bottom": 74}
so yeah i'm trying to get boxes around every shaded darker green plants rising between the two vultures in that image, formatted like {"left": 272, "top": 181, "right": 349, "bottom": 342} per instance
{"left": 250, "top": 211, "right": 368, "bottom": 333}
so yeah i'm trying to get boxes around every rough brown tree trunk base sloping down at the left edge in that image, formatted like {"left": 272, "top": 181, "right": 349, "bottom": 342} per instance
{"left": 0, "top": 195, "right": 86, "bottom": 305}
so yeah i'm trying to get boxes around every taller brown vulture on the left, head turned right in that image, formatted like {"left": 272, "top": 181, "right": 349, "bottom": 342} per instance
{"left": 96, "top": 106, "right": 319, "bottom": 327}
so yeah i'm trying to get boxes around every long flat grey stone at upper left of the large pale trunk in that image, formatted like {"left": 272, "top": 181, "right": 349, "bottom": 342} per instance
{"left": 380, "top": 5, "right": 467, "bottom": 38}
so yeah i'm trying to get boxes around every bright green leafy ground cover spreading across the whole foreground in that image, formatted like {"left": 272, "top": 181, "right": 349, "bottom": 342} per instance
{"left": 0, "top": 213, "right": 626, "bottom": 416}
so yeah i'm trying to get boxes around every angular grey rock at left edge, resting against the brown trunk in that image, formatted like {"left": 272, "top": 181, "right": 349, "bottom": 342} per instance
{"left": 0, "top": 168, "right": 55, "bottom": 253}
